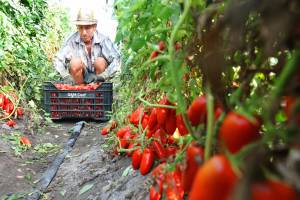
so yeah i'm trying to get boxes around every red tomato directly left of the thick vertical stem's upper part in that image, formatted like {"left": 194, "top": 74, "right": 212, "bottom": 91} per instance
{"left": 187, "top": 96, "right": 207, "bottom": 126}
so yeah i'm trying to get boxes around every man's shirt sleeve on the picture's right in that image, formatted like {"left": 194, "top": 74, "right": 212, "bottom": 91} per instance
{"left": 101, "top": 38, "right": 121, "bottom": 78}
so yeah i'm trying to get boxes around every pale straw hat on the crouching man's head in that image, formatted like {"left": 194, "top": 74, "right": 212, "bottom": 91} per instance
{"left": 75, "top": 8, "right": 97, "bottom": 25}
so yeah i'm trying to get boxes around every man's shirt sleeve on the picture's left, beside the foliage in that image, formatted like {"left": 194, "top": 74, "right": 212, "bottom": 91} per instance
{"left": 53, "top": 44, "right": 72, "bottom": 78}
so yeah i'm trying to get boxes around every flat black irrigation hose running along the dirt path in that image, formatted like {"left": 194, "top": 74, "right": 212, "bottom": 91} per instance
{"left": 26, "top": 121, "right": 85, "bottom": 200}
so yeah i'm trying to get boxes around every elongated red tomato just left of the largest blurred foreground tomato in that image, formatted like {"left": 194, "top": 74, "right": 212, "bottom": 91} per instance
{"left": 182, "top": 143, "right": 204, "bottom": 192}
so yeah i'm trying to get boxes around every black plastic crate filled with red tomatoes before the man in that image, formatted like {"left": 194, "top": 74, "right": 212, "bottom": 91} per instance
{"left": 43, "top": 82, "right": 113, "bottom": 121}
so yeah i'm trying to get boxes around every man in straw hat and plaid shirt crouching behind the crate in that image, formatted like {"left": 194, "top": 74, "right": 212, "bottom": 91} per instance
{"left": 54, "top": 9, "right": 120, "bottom": 84}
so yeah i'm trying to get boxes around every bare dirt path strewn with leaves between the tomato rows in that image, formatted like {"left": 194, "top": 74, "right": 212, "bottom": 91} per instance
{"left": 0, "top": 121, "right": 149, "bottom": 200}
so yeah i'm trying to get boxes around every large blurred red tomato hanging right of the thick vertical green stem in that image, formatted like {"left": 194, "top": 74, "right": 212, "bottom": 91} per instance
{"left": 219, "top": 112, "right": 260, "bottom": 153}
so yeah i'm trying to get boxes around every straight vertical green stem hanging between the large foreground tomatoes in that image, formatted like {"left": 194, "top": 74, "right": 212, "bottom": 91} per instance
{"left": 204, "top": 84, "right": 214, "bottom": 162}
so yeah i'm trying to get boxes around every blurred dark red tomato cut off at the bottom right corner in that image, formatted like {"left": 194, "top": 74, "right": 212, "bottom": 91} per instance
{"left": 251, "top": 180, "right": 297, "bottom": 200}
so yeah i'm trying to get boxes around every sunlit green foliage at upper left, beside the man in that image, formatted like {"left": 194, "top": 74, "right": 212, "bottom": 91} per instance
{"left": 0, "top": 0, "right": 68, "bottom": 104}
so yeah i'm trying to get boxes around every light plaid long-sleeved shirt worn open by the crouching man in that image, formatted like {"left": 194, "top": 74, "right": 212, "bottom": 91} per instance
{"left": 54, "top": 31, "right": 120, "bottom": 78}
